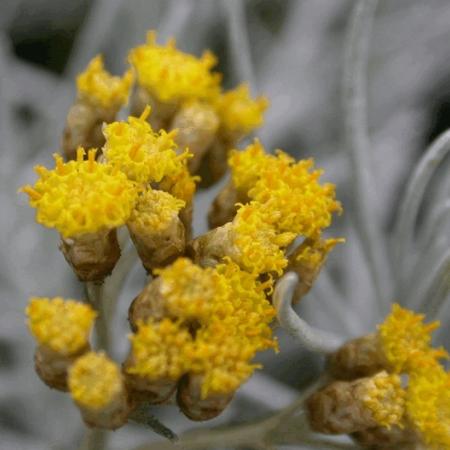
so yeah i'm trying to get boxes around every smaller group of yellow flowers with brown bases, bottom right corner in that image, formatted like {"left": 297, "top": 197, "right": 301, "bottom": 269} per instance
{"left": 307, "top": 304, "right": 450, "bottom": 450}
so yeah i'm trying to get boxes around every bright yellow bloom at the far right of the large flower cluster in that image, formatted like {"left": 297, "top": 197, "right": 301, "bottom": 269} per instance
{"left": 229, "top": 141, "right": 341, "bottom": 237}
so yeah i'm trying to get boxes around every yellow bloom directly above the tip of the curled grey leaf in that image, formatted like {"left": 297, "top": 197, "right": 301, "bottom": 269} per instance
{"left": 232, "top": 202, "right": 295, "bottom": 274}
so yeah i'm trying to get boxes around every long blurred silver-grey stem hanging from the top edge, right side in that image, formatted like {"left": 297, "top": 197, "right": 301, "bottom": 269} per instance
{"left": 343, "top": 0, "right": 391, "bottom": 316}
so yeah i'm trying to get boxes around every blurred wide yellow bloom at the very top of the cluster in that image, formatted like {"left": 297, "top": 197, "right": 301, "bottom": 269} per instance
{"left": 128, "top": 31, "right": 220, "bottom": 102}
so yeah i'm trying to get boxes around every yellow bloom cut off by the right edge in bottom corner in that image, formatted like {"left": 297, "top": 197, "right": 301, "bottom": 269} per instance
{"left": 406, "top": 358, "right": 450, "bottom": 450}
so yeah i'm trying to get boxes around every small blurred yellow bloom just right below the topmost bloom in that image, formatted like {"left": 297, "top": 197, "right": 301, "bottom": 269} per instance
{"left": 215, "top": 84, "right": 269, "bottom": 136}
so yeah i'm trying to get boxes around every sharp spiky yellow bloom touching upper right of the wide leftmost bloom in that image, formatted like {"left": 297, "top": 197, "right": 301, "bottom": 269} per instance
{"left": 103, "top": 107, "right": 189, "bottom": 183}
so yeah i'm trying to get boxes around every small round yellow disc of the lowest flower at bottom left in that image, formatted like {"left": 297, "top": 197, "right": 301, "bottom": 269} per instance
{"left": 68, "top": 352, "right": 124, "bottom": 410}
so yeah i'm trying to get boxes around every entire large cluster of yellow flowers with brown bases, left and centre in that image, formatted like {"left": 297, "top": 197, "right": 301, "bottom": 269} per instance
{"left": 22, "top": 29, "right": 342, "bottom": 429}
